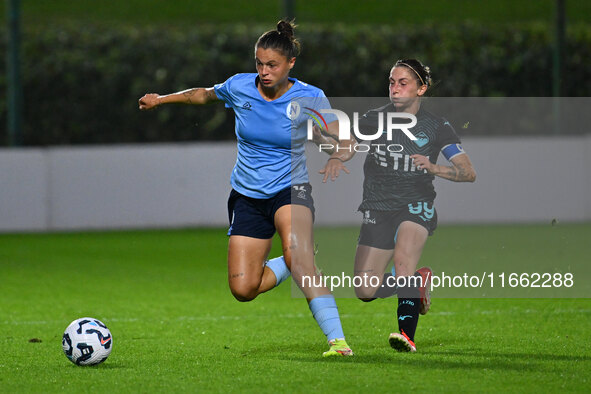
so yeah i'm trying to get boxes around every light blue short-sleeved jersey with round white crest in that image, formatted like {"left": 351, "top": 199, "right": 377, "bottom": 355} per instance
{"left": 214, "top": 73, "right": 330, "bottom": 198}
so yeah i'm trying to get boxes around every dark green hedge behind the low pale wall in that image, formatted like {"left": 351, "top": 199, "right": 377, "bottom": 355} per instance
{"left": 0, "top": 24, "right": 591, "bottom": 145}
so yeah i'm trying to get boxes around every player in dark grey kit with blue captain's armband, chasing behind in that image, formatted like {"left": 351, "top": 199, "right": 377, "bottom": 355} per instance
{"left": 321, "top": 59, "right": 476, "bottom": 352}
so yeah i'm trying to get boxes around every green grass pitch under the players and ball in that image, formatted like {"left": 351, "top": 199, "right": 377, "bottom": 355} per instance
{"left": 0, "top": 224, "right": 591, "bottom": 393}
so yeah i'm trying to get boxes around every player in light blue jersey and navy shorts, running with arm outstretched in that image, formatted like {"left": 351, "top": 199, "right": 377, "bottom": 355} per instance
{"left": 139, "top": 21, "right": 353, "bottom": 357}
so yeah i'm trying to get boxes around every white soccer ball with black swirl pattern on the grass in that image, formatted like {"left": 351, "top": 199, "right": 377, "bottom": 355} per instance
{"left": 62, "top": 317, "right": 113, "bottom": 365}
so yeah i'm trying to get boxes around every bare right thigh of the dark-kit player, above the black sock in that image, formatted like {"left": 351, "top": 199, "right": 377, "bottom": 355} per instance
{"left": 394, "top": 221, "right": 429, "bottom": 276}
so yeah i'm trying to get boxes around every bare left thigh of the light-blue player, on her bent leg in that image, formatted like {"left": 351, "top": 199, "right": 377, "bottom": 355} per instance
{"left": 228, "top": 235, "right": 271, "bottom": 288}
